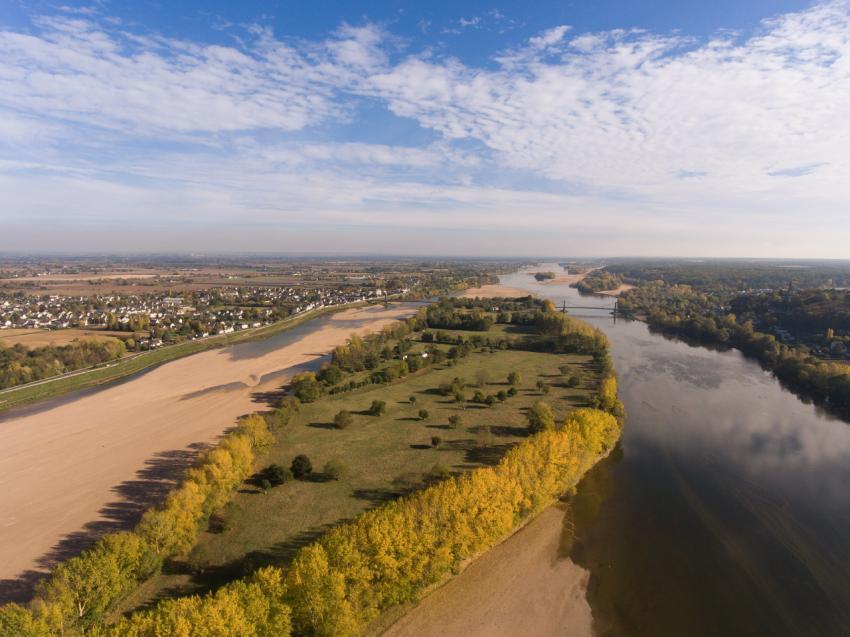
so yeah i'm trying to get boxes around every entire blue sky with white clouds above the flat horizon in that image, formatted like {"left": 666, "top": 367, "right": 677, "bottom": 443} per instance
{"left": 0, "top": 0, "right": 850, "bottom": 258}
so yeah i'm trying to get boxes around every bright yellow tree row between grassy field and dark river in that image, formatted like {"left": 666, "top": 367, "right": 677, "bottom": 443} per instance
{"left": 92, "top": 409, "right": 620, "bottom": 637}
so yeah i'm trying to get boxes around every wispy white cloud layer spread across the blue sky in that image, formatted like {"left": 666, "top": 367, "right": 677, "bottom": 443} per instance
{"left": 0, "top": 0, "right": 850, "bottom": 253}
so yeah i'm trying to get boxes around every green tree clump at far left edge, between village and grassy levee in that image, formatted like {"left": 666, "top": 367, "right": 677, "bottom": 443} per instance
{"left": 0, "top": 338, "right": 127, "bottom": 389}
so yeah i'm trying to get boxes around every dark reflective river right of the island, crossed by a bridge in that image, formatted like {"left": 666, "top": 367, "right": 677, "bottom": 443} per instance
{"left": 501, "top": 264, "right": 850, "bottom": 637}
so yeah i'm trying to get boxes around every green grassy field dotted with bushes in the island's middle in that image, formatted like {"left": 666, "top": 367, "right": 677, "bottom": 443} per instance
{"left": 125, "top": 326, "right": 598, "bottom": 608}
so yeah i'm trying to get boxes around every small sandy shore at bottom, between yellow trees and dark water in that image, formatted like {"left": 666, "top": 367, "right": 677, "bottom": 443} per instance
{"left": 384, "top": 507, "right": 593, "bottom": 637}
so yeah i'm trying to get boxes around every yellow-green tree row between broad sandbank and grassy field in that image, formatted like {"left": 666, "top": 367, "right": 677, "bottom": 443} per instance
{"left": 0, "top": 415, "right": 272, "bottom": 637}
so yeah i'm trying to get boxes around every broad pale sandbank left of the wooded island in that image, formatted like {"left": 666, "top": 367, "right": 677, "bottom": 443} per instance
{"left": 0, "top": 306, "right": 412, "bottom": 601}
